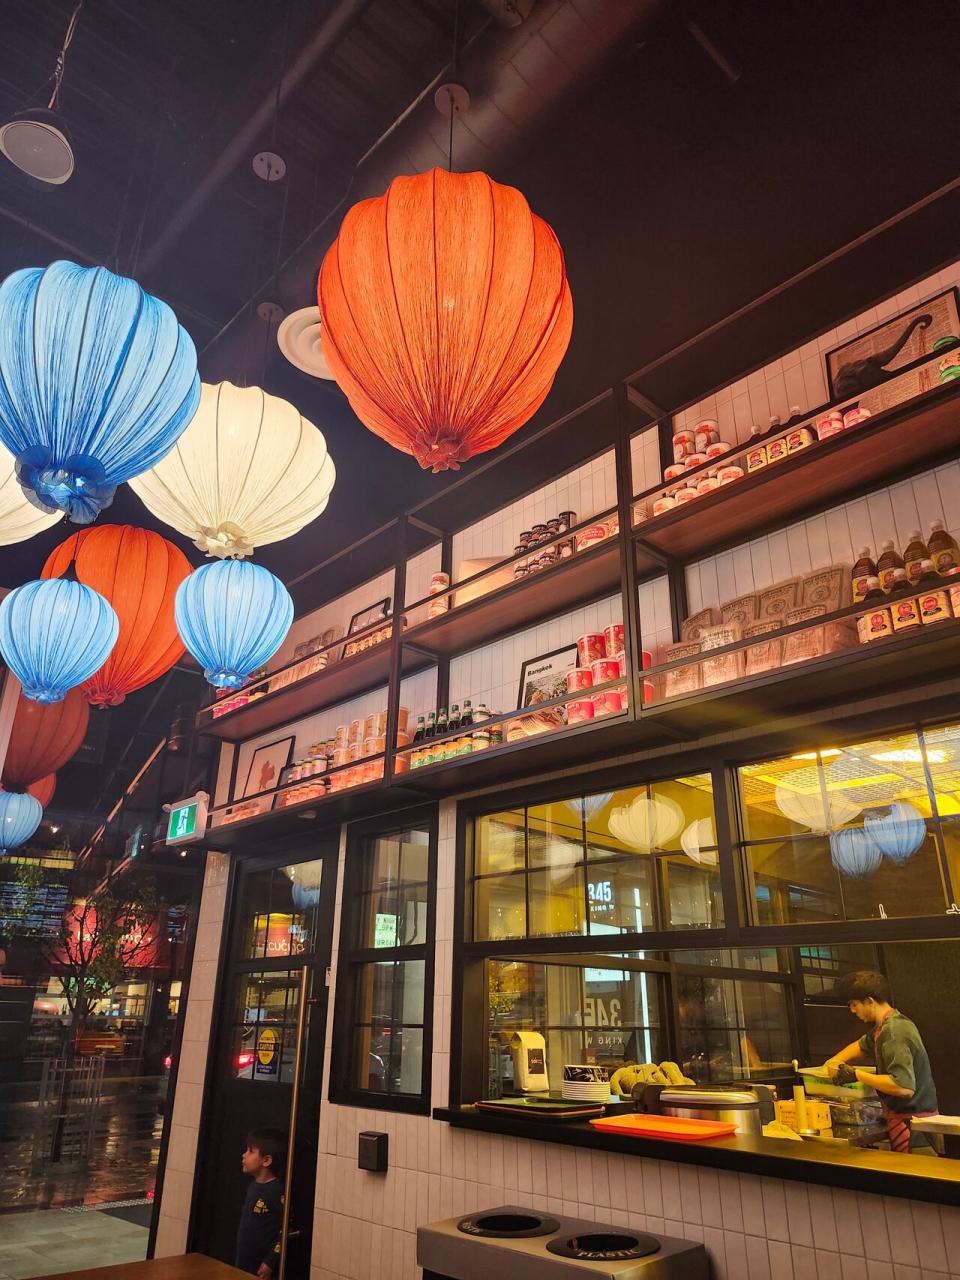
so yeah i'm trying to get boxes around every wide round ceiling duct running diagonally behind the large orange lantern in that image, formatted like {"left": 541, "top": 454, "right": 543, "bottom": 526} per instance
{"left": 202, "top": 0, "right": 668, "bottom": 379}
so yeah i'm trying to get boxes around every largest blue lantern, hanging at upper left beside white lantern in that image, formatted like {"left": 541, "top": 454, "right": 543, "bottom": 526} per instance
{"left": 0, "top": 262, "right": 200, "bottom": 525}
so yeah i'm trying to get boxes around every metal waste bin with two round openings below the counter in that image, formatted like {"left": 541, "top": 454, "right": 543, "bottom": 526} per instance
{"left": 417, "top": 1204, "right": 709, "bottom": 1280}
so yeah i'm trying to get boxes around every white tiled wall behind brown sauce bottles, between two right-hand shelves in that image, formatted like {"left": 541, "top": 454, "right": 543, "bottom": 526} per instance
{"left": 686, "top": 462, "right": 960, "bottom": 613}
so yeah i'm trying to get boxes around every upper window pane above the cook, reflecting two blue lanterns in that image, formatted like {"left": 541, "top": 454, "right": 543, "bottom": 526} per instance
{"left": 737, "top": 730, "right": 960, "bottom": 924}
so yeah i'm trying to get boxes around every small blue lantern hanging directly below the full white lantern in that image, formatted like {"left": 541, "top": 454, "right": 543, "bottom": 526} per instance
{"left": 174, "top": 561, "right": 293, "bottom": 689}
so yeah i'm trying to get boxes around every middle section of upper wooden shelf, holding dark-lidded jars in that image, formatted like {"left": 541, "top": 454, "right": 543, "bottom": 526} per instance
{"left": 403, "top": 535, "right": 620, "bottom": 658}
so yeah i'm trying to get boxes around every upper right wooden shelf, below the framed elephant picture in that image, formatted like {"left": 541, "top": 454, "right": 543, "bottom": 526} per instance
{"left": 634, "top": 383, "right": 960, "bottom": 562}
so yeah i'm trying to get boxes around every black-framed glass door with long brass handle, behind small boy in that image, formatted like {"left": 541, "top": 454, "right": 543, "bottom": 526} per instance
{"left": 192, "top": 835, "right": 337, "bottom": 1280}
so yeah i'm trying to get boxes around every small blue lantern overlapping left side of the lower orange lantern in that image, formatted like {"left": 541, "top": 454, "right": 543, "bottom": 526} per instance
{"left": 0, "top": 577, "right": 120, "bottom": 703}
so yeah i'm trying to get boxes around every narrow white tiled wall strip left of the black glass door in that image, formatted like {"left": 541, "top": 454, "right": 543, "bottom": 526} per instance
{"left": 156, "top": 852, "right": 230, "bottom": 1258}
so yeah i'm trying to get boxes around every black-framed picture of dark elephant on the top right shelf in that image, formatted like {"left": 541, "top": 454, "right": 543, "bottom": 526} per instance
{"left": 826, "top": 288, "right": 960, "bottom": 413}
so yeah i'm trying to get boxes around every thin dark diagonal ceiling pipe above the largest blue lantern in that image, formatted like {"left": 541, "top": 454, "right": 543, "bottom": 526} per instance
{"left": 140, "top": 0, "right": 370, "bottom": 274}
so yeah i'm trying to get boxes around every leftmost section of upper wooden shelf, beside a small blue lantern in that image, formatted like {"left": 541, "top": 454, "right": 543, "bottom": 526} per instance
{"left": 197, "top": 640, "right": 429, "bottom": 742}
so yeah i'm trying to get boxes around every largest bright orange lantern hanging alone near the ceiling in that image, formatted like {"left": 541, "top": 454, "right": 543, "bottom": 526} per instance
{"left": 317, "top": 169, "right": 573, "bottom": 471}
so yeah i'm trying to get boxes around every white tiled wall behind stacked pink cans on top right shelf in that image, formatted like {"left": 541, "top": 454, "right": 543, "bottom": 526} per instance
{"left": 632, "top": 260, "right": 960, "bottom": 493}
